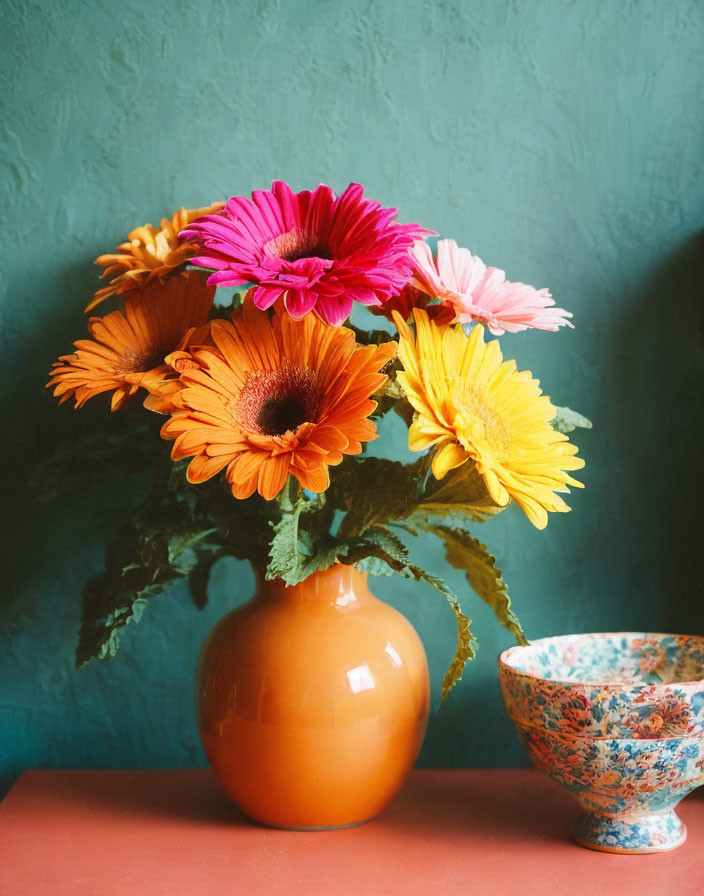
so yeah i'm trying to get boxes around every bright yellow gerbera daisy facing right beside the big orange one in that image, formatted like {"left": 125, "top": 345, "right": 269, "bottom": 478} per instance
{"left": 394, "top": 309, "right": 584, "bottom": 529}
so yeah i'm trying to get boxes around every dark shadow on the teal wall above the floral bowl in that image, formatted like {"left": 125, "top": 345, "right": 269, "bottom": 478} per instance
{"left": 603, "top": 232, "right": 704, "bottom": 634}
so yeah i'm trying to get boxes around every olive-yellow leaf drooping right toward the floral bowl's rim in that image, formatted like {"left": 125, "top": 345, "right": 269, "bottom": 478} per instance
{"left": 420, "top": 525, "right": 528, "bottom": 644}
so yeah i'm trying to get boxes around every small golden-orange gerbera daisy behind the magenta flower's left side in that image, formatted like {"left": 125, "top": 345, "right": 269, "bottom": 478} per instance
{"left": 86, "top": 202, "right": 224, "bottom": 311}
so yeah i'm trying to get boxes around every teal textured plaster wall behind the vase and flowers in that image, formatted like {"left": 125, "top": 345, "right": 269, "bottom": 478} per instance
{"left": 0, "top": 0, "right": 704, "bottom": 800}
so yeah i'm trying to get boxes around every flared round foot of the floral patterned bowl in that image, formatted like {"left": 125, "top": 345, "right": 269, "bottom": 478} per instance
{"left": 572, "top": 810, "right": 687, "bottom": 855}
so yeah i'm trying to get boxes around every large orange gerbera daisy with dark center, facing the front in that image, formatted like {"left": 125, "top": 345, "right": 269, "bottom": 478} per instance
{"left": 161, "top": 299, "right": 396, "bottom": 500}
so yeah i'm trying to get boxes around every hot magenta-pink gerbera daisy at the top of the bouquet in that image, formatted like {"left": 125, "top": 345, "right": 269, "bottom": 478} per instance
{"left": 180, "top": 181, "right": 431, "bottom": 326}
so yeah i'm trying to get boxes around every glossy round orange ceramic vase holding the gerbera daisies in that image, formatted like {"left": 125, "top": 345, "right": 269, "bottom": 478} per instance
{"left": 197, "top": 564, "right": 429, "bottom": 828}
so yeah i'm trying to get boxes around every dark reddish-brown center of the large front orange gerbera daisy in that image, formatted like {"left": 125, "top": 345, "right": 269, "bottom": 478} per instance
{"left": 232, "top": 363, "right": 323, "bottom": 436}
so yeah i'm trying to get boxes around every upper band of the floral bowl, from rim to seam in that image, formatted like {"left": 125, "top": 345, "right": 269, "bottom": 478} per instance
{"left": 499, "top": 634, "right": 704, "bottom": 738}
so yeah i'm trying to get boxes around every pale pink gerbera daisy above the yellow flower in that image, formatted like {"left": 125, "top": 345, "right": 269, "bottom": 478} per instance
{"left": 411, "top": 240, "right": 572, "bottom": 336}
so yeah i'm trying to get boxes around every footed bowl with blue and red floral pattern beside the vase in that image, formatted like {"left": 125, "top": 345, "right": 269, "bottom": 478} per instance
{"left": 499, "top": 632, "right": 704, "bottom": 853}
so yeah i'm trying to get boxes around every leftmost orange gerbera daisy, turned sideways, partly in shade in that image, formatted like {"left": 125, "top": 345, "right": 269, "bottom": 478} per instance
{"left": 47, "top": 271, "right": 215, "bottom": 411}
